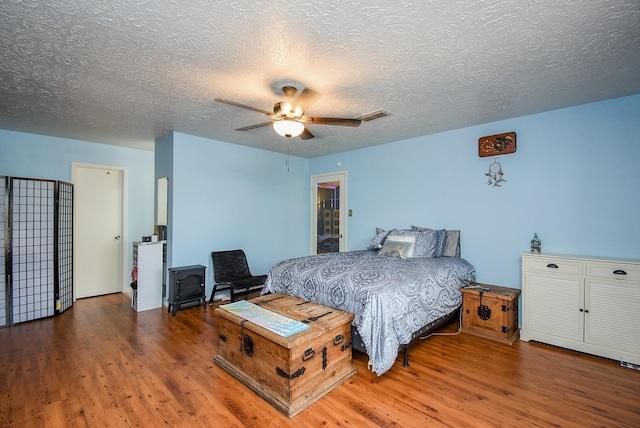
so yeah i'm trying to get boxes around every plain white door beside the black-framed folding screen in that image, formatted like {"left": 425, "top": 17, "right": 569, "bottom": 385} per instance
{"left": 73, "top": 164, "right": 126, "bottom": 299}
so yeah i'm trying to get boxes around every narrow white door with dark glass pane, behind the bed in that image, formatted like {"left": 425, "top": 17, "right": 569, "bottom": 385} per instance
{"left": 310, "top": 171, "right": 347, "bottom": 254}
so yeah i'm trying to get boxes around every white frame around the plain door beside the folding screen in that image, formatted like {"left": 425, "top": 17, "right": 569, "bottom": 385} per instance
{"left": 71, "top": 162, "right": 129, "bottom": 302}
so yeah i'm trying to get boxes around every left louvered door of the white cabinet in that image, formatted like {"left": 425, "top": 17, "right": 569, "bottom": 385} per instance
{"left": 523, "top": 273, "right": 584, "bottom": 341}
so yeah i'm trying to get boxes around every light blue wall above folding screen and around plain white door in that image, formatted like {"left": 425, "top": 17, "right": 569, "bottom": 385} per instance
{"left": 0, "top": 130, "right": 154, "bottom": 284}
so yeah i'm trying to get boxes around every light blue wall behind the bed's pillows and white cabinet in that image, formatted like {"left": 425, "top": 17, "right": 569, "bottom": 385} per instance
{"left": 309, "top": 96, "right": 640, "bottom": 288}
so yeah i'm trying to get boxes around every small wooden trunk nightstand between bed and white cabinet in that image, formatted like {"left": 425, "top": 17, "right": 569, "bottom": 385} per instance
{"left": 460, "top": 283, "right": 520, "bottom": 345}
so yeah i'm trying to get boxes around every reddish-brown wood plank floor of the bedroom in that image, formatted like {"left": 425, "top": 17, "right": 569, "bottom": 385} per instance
{"left": 0, "top": 294, "right": 640, "bottom": 427}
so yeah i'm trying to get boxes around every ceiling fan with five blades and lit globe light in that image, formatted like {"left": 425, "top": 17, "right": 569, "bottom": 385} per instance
{"left": 215, "top": 86, "right": 362, "bottom": 140}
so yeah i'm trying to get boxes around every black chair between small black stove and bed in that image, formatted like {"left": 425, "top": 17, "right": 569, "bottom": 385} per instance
{"left": 209, "top": 250, "right": 267, "bottom": 304}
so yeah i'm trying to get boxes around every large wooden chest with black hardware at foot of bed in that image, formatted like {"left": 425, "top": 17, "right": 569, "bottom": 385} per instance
{"left": 214, "top": 294, "right": 356, "bottom": 417}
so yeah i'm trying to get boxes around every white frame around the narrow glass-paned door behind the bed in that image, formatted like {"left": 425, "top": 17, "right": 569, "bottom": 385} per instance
{"left": 309, "top": 171, "right": 348, "bottom": 254}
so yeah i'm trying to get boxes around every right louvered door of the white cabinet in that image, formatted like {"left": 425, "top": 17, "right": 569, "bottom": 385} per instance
{"left": 585, "top": 278, "right": 640, "bottom": 354}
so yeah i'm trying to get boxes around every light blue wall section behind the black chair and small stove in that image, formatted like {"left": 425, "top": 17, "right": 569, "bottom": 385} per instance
{"left": 161, "top": 132, "right": 309, "bottom": 294}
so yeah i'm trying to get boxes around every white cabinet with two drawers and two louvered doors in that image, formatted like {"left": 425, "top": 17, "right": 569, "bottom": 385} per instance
{"left": 520, "top": 253, "right": 640, "bottom": 364}
